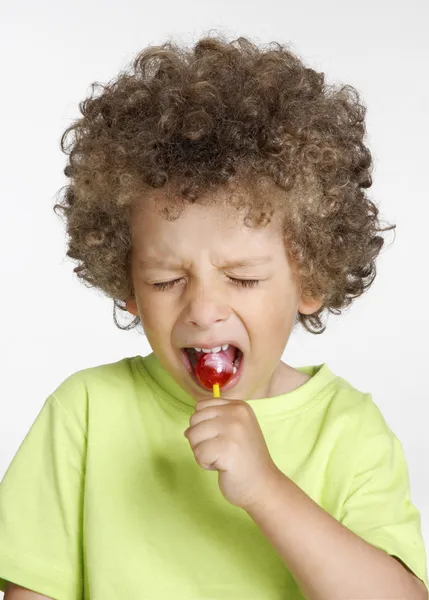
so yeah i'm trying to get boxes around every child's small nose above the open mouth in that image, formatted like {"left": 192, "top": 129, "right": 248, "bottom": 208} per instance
{"left": 185, "top": 285, "right": 231, "bottom": 330}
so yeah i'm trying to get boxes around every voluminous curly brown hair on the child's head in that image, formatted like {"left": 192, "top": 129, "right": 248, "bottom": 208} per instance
{"left": 54, "top": 36, "right": 395, "bottom": 333}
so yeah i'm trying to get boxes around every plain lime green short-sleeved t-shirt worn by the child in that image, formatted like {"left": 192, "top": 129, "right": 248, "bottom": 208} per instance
{"left": 0, "top": 354, "right": 428, "bottom": 600}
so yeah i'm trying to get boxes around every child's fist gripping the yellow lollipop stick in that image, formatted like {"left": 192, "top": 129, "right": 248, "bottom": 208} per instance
{"left": 184, "top": 398, "right": 284, "bottom": 510}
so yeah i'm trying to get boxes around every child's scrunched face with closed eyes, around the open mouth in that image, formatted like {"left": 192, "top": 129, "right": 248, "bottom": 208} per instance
{"left": 127, "top": 191, "right": 321, "bottom": 399}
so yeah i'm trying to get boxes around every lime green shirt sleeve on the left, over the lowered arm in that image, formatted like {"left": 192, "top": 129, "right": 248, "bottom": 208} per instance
{"left": 0, "top": 384, "right": 86, "bottom": 600}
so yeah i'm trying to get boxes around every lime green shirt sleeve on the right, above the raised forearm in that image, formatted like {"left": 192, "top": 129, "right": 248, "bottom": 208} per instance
{"left": 340, "top": 396, "right": 429, "bottom": 589}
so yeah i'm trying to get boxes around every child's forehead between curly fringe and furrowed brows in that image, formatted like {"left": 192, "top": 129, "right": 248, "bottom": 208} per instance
{"left": 131, "top": 195, "right": 284, "bottom": 260}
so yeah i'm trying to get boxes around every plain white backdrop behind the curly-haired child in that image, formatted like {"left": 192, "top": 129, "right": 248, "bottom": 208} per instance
{"left": 0, "top": 0, "right": 429, "bottom": 592}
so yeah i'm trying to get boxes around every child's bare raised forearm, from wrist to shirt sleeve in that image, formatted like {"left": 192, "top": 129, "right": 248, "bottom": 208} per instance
{"left": 246, "top": 473, "right": 428, "bottom": 600}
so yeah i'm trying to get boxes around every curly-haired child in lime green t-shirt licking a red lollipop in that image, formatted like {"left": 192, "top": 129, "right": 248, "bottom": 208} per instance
{"left": 0, "top": 37, "right": 428, "bottom": 600}
